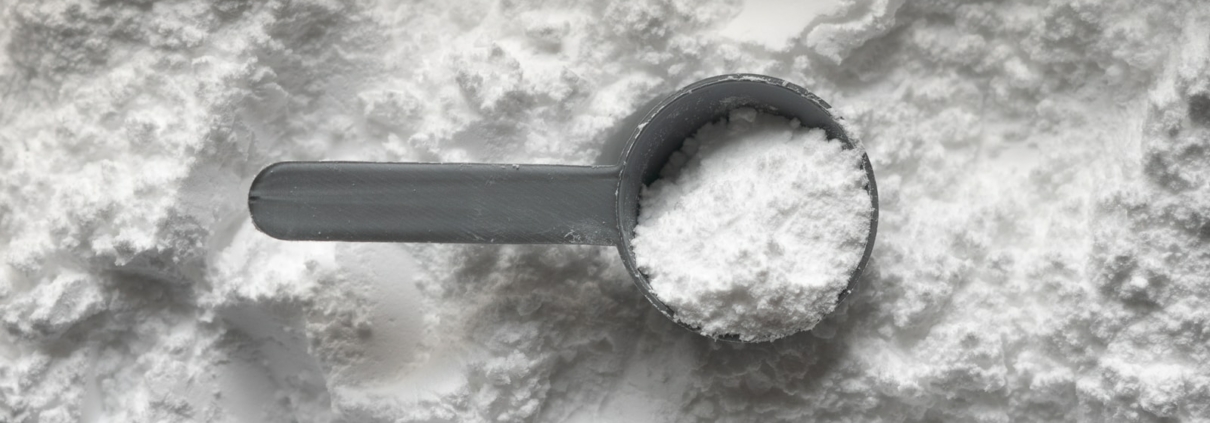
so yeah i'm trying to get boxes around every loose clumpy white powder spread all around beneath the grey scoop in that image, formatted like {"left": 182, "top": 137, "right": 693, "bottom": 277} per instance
{"left": 0, "top": 0, "right": 1210, "bottom": 422}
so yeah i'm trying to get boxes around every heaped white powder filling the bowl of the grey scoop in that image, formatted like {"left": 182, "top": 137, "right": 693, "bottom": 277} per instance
{"left": 633, "top": 109, "right": 872, "bottom": 341}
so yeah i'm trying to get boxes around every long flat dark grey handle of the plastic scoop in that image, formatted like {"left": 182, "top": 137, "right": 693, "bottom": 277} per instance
{"left": 248, "top": 162, "right": 621, "bottom": 245}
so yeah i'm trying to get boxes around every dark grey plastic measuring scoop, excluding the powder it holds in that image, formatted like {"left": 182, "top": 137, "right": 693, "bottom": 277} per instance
{"left": 248, "top": 74, "right": 878, "bottom": 341}
